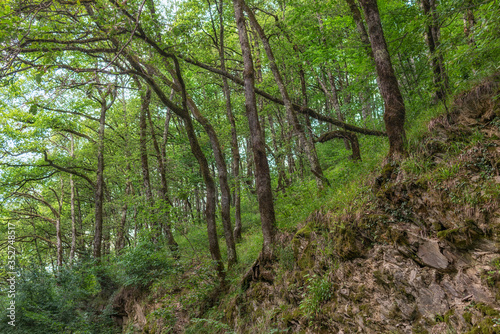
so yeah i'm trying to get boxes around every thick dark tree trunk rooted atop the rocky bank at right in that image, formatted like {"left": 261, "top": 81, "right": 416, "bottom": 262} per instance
{"left": 360, "top": 0, "right": 406, "bottom": 160}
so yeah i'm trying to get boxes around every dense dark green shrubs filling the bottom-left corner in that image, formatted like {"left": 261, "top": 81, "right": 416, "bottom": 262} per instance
{"left": 0, "top": 264, "right": 117, "bottom": 334}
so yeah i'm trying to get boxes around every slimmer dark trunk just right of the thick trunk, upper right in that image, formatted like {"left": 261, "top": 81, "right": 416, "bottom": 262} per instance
{"left": 421, "top": 0, "right": 448, "bottom": 101}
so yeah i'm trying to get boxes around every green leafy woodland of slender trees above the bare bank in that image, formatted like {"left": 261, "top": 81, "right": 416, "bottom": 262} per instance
{"left": 0, "top": 0, "right": 500, "bottom": 330}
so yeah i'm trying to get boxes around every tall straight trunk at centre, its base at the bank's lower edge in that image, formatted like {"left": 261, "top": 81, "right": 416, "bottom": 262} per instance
{"left": 233, "top": 0, "right": 276, "bottom": 262}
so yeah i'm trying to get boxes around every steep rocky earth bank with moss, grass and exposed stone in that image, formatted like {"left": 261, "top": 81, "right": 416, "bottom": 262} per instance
{"left": 118, "top": 76, "right": 500, "bottom": 333}
